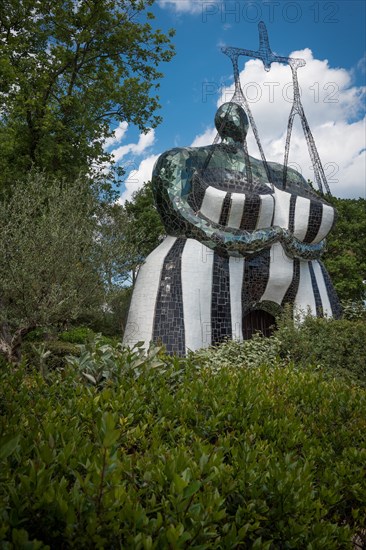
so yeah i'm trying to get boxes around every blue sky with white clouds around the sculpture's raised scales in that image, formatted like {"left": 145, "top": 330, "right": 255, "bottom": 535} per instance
{"left": 108, "top": 0, "right": 366, "bottom": 200}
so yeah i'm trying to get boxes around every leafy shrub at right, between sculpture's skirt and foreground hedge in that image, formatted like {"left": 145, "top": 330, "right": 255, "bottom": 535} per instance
{"left": 276, "top": 315, "right": 366, "bottom": 386}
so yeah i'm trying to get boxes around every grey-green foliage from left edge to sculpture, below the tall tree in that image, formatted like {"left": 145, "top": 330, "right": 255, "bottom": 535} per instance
{"left": 0, "top": 171, "right": 154, "bottom": 362}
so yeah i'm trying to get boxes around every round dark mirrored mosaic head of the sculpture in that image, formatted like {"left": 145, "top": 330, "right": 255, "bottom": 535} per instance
{"left": 215, "top": 103, "right": 249, "bottom": 143}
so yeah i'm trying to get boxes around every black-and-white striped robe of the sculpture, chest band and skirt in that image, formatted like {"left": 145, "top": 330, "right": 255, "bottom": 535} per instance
{"left": 124, "top": 178, "right": 340, "bottom": 355}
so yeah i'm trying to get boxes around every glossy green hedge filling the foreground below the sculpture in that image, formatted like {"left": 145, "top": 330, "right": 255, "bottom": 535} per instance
{"left": 0, "top": 343, "right": 366, "bottom": 550}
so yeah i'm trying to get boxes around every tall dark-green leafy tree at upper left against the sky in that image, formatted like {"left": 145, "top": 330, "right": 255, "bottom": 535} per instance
{"left": 0, "top": 0, "right": 174, "bottom": 189}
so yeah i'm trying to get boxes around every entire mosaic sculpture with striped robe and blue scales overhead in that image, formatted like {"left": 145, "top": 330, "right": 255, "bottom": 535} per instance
{"left": 124, "top": 23, "right": 341, "bottom": 355}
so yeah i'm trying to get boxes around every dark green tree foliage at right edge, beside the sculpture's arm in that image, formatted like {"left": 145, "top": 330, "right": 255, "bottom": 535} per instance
{"left": 324, "top": 197, "right": 366, "bottom": 301}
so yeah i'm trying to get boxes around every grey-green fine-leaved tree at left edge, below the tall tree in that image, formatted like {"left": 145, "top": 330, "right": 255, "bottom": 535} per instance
{"left": 0, "top": 172, "right": 103, "bottom": 362}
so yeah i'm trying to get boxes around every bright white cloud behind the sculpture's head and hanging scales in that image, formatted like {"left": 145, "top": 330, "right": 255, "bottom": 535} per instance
{"left": 192, "top": 48, "right": 366, "bottom": 198}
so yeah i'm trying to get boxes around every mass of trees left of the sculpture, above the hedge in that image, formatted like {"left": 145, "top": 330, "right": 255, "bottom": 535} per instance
{"left": 0, "top": 0, "right": 174, "bottom": 363}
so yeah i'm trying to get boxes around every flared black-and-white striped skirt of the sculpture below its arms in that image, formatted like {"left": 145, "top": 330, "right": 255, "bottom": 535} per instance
{"left": 123, "top": 236, "right": 341, "bottom": 356}
